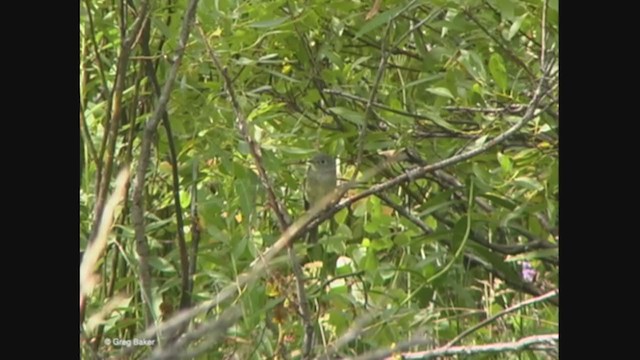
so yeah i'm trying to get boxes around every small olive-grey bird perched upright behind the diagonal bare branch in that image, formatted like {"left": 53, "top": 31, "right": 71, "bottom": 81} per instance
{"left": 304, "top": 153, "right": 338, "bottom": 244}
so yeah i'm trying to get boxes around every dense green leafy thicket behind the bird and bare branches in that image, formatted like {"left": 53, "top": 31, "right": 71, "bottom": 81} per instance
{"left": 79, "top": 0, "right": 559, "bottom": 359}
